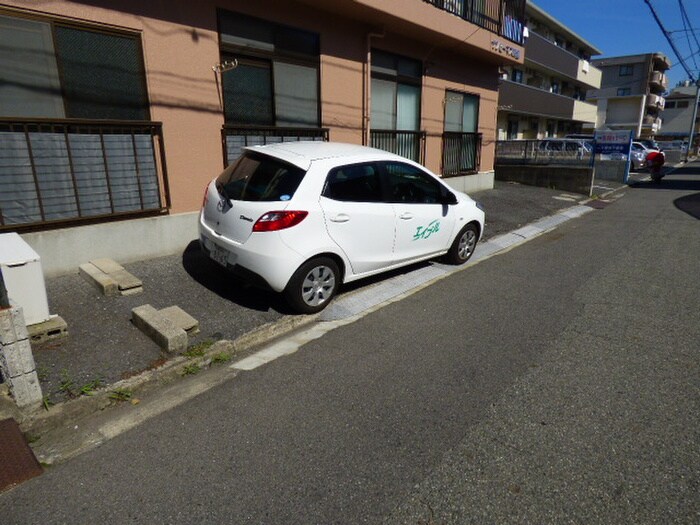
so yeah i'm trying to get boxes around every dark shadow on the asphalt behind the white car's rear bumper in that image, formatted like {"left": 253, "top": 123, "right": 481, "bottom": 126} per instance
{"left": 182, "top": 240, "right": 291, "bottom": 314}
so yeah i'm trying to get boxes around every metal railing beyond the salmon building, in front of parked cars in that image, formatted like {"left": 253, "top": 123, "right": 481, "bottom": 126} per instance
{"left": 495, "top": 139, "right": 593, "bottom": 166}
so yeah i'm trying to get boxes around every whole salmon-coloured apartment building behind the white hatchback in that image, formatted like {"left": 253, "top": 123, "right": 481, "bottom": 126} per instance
{"left": 0, "top": 0, "right": 524, "bottom": 275}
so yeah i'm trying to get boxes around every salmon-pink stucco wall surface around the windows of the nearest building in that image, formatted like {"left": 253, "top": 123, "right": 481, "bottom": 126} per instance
{"left": 0, "top": 0, "right": 520, "bottom": 213}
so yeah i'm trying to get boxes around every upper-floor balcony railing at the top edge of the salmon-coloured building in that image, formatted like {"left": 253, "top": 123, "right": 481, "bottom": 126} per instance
{"left": 424, "top": 0, "right": 526, "bottom": 45}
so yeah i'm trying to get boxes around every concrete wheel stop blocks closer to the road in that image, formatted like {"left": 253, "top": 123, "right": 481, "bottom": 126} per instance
{"left": 131, "top": 304, "right": 199, "bottom": 354}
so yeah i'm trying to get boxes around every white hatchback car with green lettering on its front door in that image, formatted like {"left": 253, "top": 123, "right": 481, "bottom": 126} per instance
{"left": 199, "top": 142, "right": 484, "bottom": 313}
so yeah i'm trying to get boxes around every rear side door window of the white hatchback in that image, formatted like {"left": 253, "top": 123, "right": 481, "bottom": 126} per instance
{"left": 323, "top": 164, "right": 381, "bottom": 202}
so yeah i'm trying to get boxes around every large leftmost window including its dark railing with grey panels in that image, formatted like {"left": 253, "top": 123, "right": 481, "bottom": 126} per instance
{"left": 0, "top": 14, "right": 162, "bottom": 229}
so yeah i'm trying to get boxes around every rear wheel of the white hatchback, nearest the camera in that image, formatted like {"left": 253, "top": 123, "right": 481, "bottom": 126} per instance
{"left": 284, "top": 257, "right": 340, "bottom": 314}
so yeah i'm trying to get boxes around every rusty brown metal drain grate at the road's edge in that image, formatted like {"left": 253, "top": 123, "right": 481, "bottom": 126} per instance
{"left": 0, "top": 419, "right": 42, "bottom": 492}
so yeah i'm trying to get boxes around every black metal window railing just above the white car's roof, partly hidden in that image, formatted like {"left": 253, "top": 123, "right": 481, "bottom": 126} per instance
{"left": 226, "top": 124, "right": 329, "bottom": 166}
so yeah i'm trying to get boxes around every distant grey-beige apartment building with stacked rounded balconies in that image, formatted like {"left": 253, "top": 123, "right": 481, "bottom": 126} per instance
{"left": 587, "top": 53, "right": 671, "bottom": 138}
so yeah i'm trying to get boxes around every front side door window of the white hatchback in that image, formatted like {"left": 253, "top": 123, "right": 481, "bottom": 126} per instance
{"left": 384, "top": 162, "right": 442, "bottom": 204}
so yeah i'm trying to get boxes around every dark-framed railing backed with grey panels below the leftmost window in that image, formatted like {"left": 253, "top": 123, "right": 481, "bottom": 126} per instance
{"left": 0, "top": 118, "right": 170, "bottom": 230}
